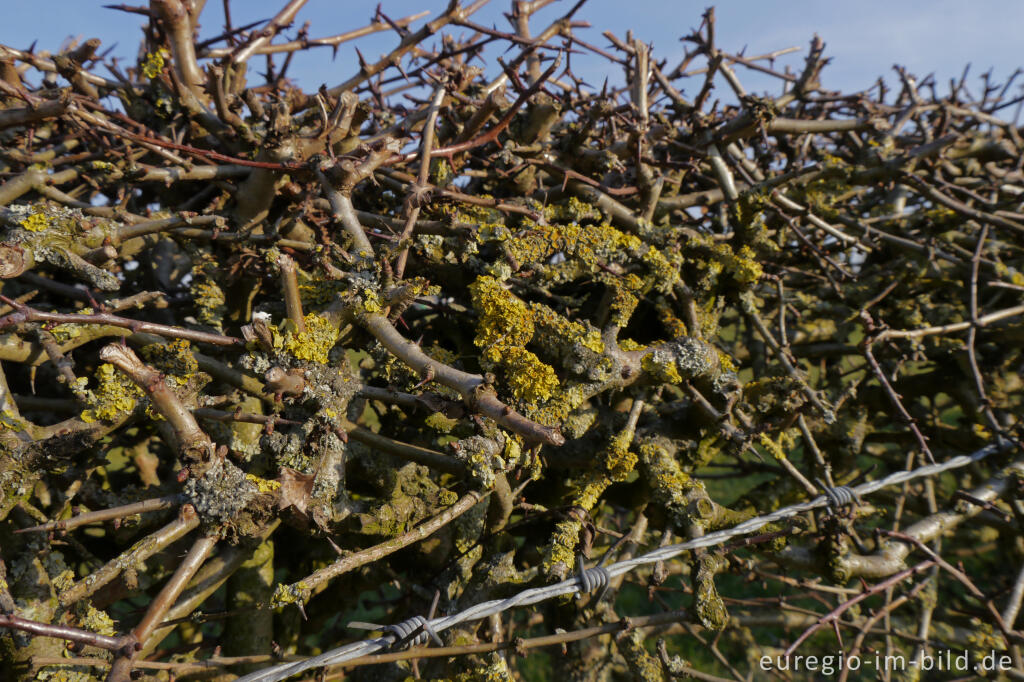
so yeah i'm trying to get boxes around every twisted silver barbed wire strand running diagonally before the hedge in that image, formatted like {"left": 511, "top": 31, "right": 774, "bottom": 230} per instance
{"left": 237, "top": 440, "right": 1010, "bottom": 682}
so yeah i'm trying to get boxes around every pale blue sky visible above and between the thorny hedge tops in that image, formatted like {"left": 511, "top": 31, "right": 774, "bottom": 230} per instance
{"left": 0, "top": 0, "right": 1024, "bottom": 104}
